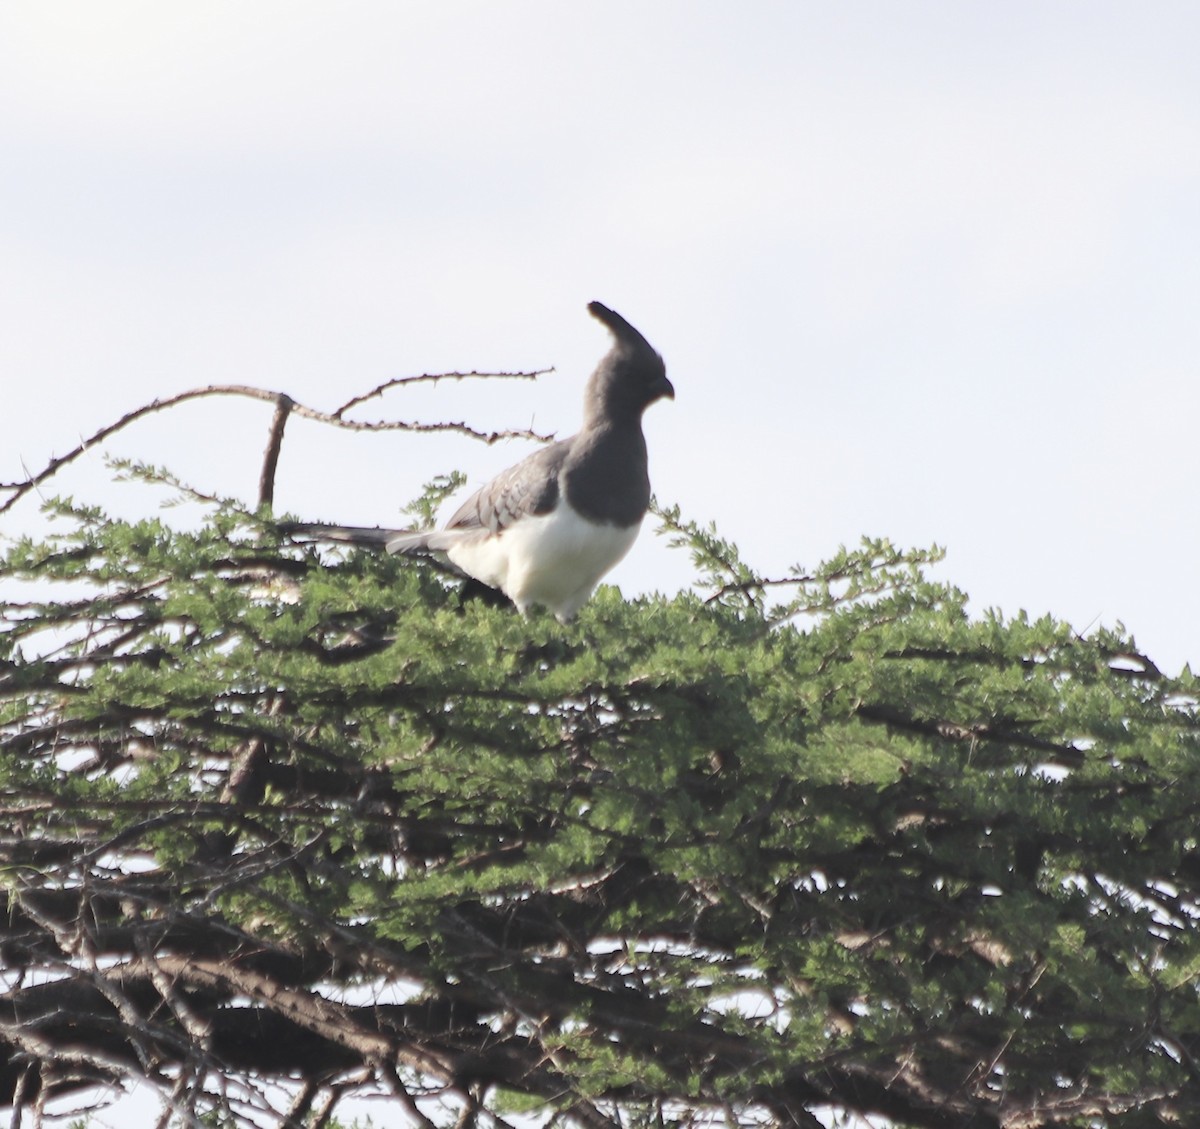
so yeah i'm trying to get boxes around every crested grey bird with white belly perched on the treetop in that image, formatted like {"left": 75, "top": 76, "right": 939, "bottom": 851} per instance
{"left": 289, "top": 301, "right": 674, "bottom": 624}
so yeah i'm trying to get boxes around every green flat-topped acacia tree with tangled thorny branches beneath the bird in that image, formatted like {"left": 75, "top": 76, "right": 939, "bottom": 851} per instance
{"left": 0, "top": 381, "right": 1200, "bottom": 1129}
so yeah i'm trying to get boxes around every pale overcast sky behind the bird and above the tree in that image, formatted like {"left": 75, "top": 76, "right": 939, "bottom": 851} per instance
{"left": 0, "top": 0, "right": 1200, "bottom": 668}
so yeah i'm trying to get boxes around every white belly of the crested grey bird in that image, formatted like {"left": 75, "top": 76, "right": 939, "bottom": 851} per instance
{"left": 446, "top": 504, "right": 641, "bottom": 623}
